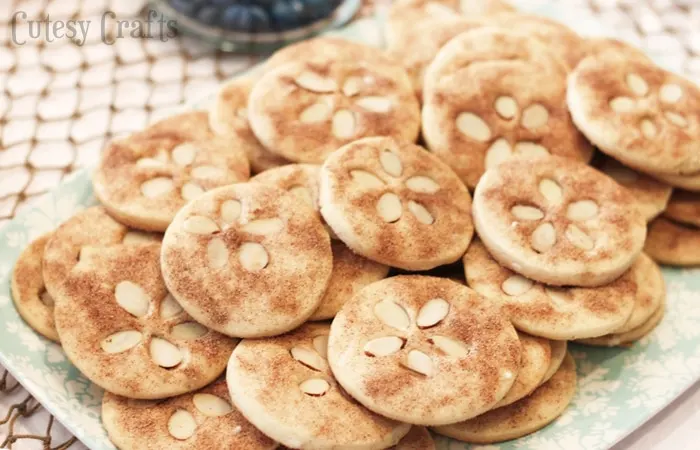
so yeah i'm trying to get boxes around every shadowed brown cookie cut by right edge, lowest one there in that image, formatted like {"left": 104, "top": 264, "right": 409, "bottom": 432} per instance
{"left": 644, "top": 217, "right": 700, "bottom": 266}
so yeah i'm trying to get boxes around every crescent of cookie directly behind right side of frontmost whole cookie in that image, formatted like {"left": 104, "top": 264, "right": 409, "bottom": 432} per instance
{"left": 491, "top": 332, "right": 552, "bottom": 409}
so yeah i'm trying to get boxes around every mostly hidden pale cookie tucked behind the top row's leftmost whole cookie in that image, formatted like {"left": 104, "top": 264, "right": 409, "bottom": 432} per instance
{"left": 209, "top": 77, "right": 289, "bottom": 173}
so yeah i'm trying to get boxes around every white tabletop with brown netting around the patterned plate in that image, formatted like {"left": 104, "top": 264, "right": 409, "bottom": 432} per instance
{"left": 0, "top": 0, "right": 700, "bottom": 450}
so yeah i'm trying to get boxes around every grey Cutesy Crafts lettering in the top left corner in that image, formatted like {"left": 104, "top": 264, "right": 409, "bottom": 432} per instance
{"left": 10, "top": 10, "right": 177, "bottom": 46}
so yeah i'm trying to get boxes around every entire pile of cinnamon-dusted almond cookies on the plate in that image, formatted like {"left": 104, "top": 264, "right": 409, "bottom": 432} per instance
{"left": 8, "top": 0, "right": 700, "bottom": 450}
